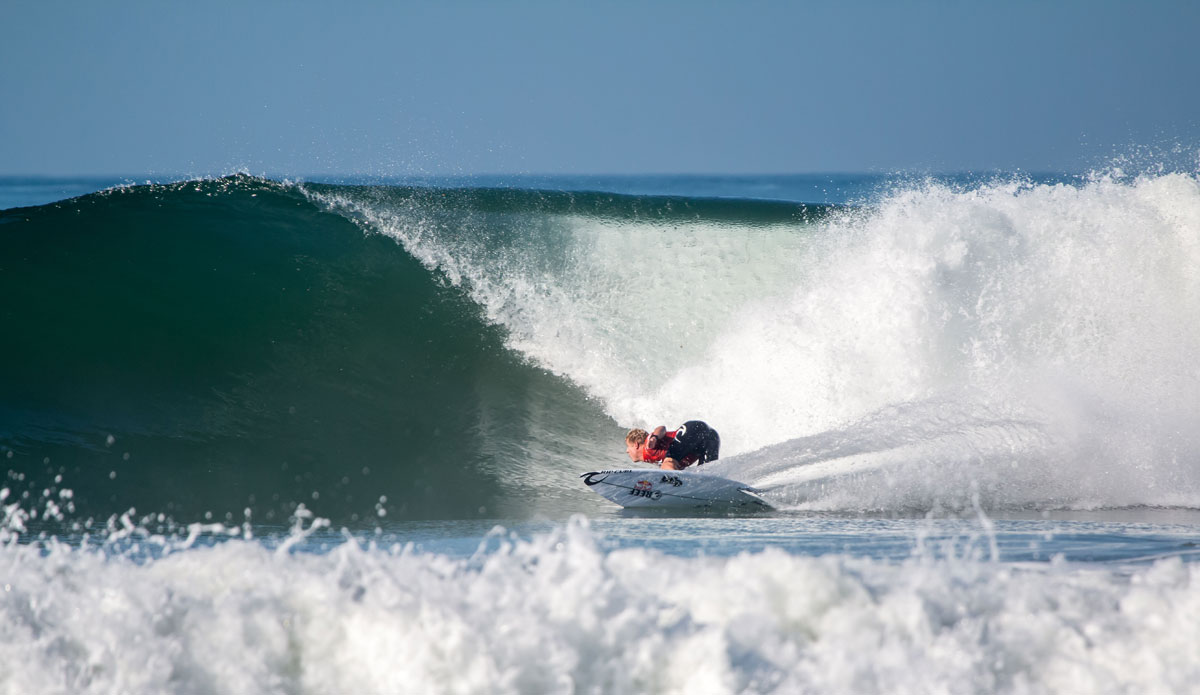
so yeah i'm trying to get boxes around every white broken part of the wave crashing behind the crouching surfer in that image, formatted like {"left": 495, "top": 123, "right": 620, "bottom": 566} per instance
{"left": 304, "top": 174, "right": 1200, "bottom": 510}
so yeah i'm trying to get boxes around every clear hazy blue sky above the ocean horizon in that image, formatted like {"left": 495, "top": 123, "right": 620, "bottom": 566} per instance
{"left": 0, "top": 0, "right": 1200, "bottom": 175}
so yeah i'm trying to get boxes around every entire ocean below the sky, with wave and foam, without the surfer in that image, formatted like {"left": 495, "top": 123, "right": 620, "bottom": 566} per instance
{"left": 0, "top": 169, "right": 1200, "bottom": 695}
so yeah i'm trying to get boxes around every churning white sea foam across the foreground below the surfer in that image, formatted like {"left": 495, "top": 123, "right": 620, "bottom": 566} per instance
{"left": 0, "top": 521, "right": 1200, "bottom": 695}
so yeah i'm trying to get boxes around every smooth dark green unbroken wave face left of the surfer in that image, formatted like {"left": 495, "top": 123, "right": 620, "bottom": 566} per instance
{"left": 0, "top": 176, "right": 620, "bottom": 522}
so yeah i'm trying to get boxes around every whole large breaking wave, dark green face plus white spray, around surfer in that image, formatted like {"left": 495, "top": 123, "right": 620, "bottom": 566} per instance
{"left": 0, "top": 173, "right": 1200, "bottom": 520}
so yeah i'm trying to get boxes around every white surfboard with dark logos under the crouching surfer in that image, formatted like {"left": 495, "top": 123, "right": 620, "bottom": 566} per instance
{"left": 580, "top": 468, "right": 770, "bottom": 509}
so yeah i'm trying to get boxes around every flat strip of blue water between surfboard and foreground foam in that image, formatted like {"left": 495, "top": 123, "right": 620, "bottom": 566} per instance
{"left": 321, "top": 510, "right": 1200, "bottom": 570}
